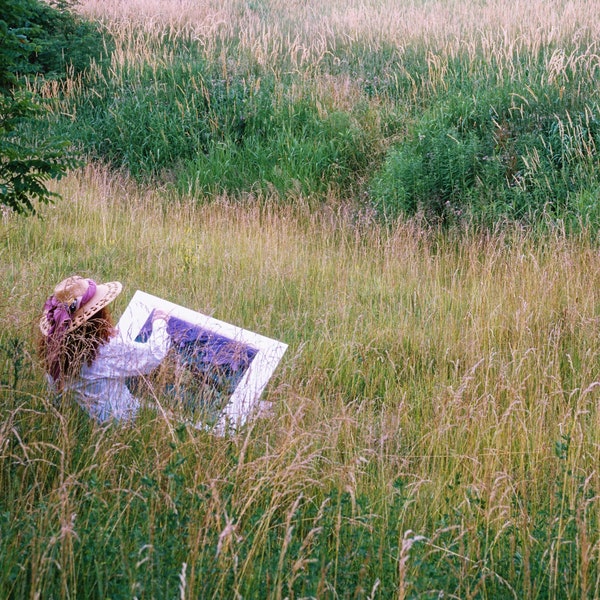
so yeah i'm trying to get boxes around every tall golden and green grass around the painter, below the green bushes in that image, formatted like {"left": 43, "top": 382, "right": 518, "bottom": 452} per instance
{"left": 0, "top": 167, "right": 600, "bottom": 598}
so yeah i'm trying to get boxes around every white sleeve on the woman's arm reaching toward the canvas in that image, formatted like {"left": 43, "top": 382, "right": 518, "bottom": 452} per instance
{"left": 90, "top": 319, "right": 171, "bottom": 377}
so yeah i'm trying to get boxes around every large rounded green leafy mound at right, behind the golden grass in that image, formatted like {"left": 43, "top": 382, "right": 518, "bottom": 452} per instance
{"left": 371, "top": 65, "right": 600, "bottom": 221}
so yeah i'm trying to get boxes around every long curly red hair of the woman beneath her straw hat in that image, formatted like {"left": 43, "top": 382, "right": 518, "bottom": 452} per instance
{"left": 38, "top": 306, "right": 116, "bottom": 392}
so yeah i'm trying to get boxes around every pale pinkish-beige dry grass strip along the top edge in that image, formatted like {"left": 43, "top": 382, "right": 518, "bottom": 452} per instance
{"left": 80, "top": 0, "right": 600, "bottom": 61}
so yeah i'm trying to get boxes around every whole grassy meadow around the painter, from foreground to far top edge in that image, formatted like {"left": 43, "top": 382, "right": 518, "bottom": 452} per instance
{"left": 0, "top": 0, "right": 600, "bottom": 599}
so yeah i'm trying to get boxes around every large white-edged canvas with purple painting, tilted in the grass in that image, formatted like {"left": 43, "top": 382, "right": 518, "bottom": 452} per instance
{"left": 118, "top": 291, "right": 287, "bottom": 432}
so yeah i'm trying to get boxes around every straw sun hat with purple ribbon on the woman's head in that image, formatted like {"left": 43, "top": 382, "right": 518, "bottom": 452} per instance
{"left": 40, "top": 275, "right": 123, "bottom": 336}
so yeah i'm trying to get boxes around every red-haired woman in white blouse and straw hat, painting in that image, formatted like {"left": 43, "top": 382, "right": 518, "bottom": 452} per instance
{"left": 40, "top": 275, "right": 170, "bottom": 422}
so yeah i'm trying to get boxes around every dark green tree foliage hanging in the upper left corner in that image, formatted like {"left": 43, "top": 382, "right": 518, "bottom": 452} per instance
{"left": 0, "top": 0, "right": 101, "bottom": 214}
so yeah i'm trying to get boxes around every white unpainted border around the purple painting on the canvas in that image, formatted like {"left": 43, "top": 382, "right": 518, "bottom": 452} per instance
{"left": 117, "top": 290, "right": 287, "bottom": 433}
